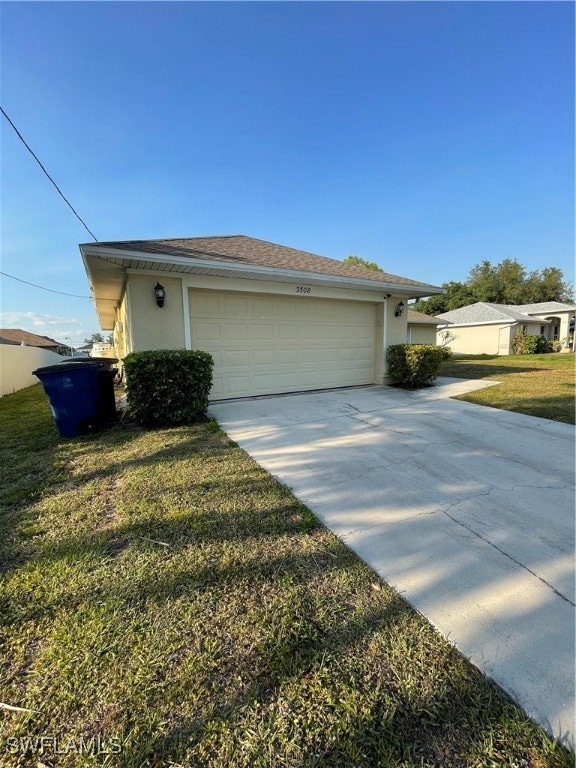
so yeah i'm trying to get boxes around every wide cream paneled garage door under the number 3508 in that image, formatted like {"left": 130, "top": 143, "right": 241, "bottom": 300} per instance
{"left": 189, "top": 290, "right": 376, "bottom": 399}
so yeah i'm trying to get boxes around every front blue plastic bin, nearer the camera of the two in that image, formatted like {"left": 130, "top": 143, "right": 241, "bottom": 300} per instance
{"left": 32, "top": 360, "right": 105, "bottom": 437}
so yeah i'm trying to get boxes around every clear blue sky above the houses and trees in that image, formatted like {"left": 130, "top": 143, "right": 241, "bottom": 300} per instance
{"left": 0, "top": 0, "right": 574, "bottom": 344}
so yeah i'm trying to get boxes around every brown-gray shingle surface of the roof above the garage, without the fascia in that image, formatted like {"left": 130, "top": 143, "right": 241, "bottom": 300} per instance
{"left": 88, "top": 235, "right": 441, "bottom": 293}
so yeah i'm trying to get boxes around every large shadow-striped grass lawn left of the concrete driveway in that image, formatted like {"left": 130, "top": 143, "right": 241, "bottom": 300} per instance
{"left": 0, "top": 386, "right": 574, "bottom": 768}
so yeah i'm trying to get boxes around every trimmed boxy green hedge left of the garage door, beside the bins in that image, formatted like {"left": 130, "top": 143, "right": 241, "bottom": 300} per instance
{"left": 124, "top": 349, "right": 214, "bottom": 426}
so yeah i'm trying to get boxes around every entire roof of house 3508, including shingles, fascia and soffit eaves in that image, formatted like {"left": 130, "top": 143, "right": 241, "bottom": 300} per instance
{"left": 80, "top": 235, "right": 443, "bottom": 329}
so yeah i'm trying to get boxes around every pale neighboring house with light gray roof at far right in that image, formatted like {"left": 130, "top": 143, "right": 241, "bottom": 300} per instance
{"left": 438, "top": 301, "right": 576, "bottom": 355}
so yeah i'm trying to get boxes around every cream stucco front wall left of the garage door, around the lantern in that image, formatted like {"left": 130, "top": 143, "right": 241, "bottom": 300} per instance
{"left": 124, "top": 274, "right": 185, "bottom": 352}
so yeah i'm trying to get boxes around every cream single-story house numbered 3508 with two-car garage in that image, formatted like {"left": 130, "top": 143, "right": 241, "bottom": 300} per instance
{"left": 80, "top": 235, "right": 442, "bottom": 399}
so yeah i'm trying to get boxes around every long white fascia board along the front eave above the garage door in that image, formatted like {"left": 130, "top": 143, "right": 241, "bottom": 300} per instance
{"left": 80, "top": 245, "right": 443, "bottom": 297}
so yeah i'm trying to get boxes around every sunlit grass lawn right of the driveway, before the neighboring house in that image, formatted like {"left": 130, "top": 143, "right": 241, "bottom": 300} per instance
{"left": 440, "top": 353, "right": 575, "bottom": 424}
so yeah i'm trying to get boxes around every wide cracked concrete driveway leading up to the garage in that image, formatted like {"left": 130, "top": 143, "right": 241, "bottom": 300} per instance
{"left": 210, "top": 380, "right": 575, "bottom": 745}
